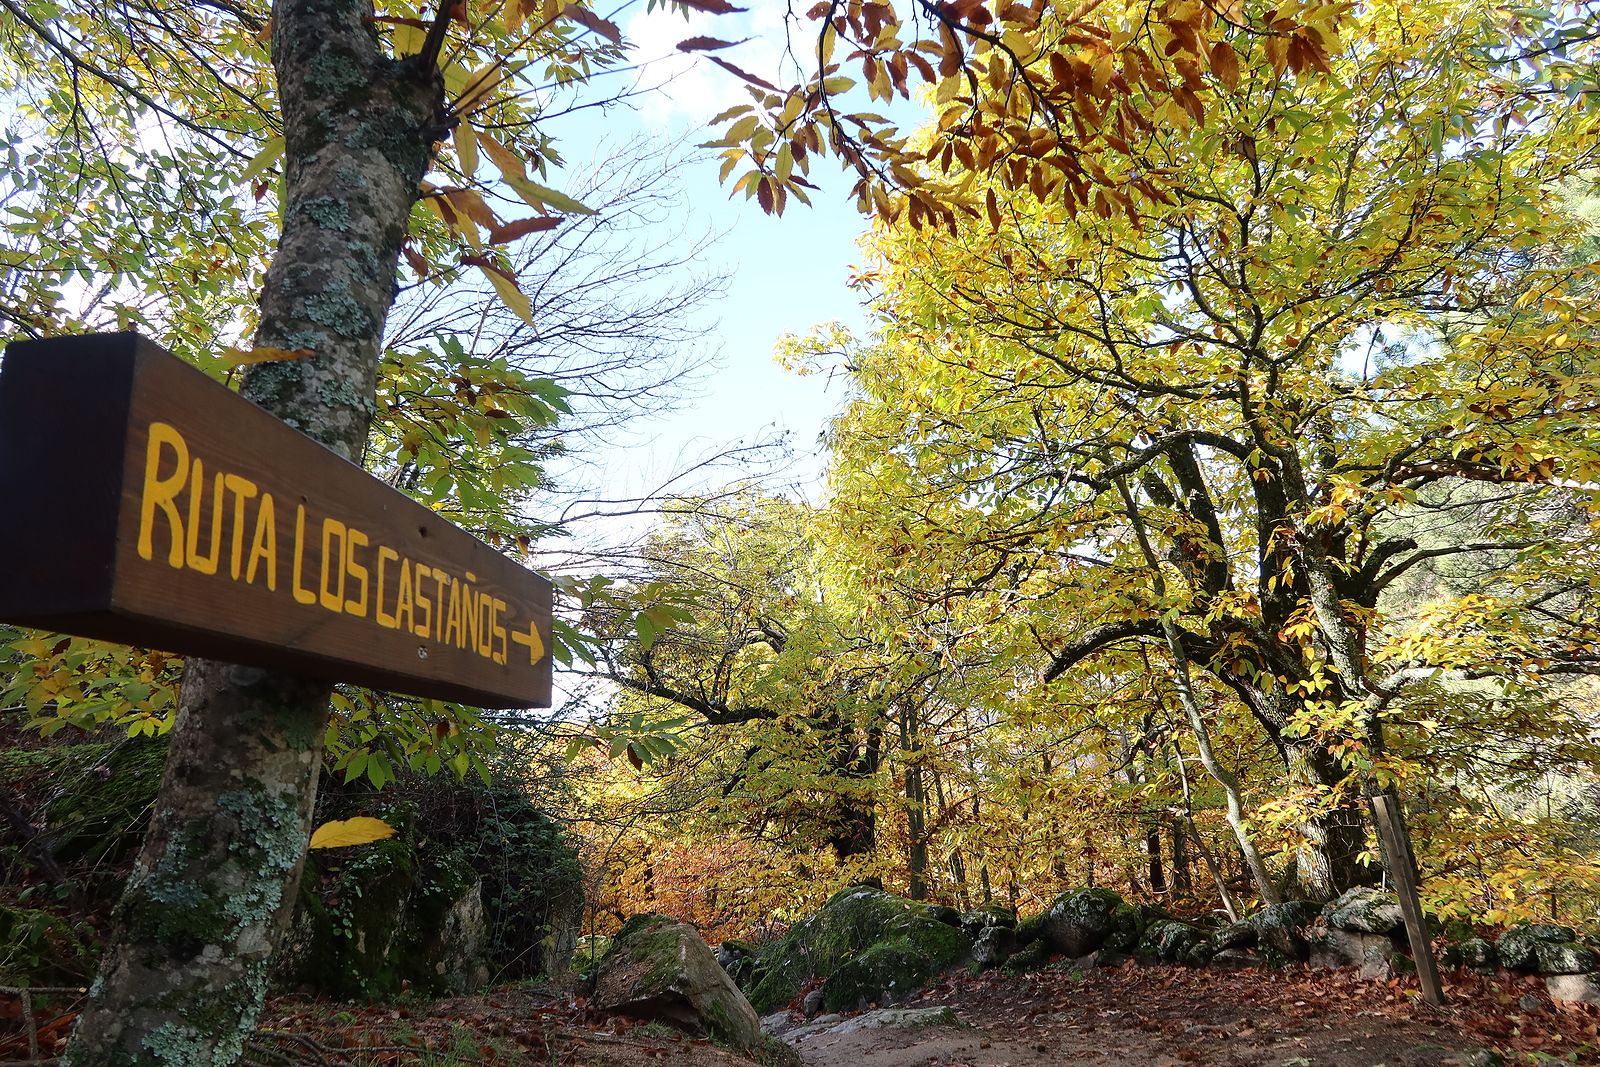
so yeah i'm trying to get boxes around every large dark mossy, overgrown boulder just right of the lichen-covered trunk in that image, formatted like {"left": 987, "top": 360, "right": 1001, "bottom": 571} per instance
{"left": 274, "top": 776, "right": 582, "bottom": 998}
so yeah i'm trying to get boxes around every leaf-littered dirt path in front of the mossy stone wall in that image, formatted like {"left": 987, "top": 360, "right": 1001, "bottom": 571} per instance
{"left": 780, "top": 966, "right": 1595, "bottom": 1067}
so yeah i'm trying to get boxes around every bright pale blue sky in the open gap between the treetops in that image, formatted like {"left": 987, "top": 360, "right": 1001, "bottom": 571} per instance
{"left": 558, "top": 3, "right": 889, "bottom": 518}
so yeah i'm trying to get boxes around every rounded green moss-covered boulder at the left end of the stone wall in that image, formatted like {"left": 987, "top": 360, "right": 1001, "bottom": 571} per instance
{"left": 746, "top": 886, "right": 973, "bottom": 1011}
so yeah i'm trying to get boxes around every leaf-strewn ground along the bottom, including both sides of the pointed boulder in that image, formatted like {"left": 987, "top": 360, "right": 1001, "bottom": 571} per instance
{"left": 0, "top": 965, "right": 1600, "bottom": 1067}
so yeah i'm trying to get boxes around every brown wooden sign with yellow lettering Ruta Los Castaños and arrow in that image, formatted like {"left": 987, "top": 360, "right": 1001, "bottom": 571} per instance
{"left": 0, "top": 333, "right": 550, "bottom": 707}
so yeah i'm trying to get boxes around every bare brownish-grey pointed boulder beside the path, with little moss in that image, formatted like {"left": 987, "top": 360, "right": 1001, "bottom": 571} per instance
{"left": 589, "top": 915, "right": 763, "bottom": 1049}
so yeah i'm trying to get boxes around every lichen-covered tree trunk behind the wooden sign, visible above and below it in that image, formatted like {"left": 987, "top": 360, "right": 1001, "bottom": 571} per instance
{"left": 64, "top": 0, "right": 443, "bottom": 1067}
